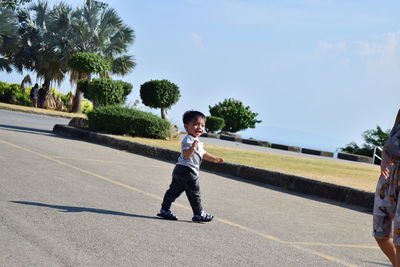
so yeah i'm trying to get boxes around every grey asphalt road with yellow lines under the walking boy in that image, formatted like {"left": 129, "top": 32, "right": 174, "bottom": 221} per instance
{"left": 0, "top": 111, "right": 390, "bottom": 266}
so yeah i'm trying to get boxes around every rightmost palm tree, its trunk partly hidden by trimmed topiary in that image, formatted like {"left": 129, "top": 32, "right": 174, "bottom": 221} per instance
{"left": 71, "top": 0, "right": 136, "bottom": 112}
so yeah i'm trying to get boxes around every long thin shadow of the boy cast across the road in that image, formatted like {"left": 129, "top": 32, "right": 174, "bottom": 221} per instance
{"left": 10, "top": 201, "right": 192, "bottom": 223}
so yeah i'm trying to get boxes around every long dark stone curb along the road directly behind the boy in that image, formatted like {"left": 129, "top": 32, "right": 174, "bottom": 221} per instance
{"left": 53, "top": 124, "right": 374, "bottom": 210}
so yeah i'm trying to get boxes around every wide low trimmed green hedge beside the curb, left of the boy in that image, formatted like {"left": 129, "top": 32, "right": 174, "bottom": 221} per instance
{"left": 88, "top": 106, "right": 171, "bottom": 139}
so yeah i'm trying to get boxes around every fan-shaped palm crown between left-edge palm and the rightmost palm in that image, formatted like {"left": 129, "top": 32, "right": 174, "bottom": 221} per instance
{"left": 14, "top": 1, "right": 72, "bottom": 89}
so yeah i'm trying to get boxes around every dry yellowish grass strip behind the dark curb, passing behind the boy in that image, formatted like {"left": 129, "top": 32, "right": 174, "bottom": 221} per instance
{"left": 116, "top": 137, "right": 379, "bottom": 192}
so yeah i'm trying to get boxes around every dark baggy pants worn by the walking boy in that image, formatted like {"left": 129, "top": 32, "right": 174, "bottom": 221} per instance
{"left": 161, "top": 165, "right": 203, "bottom": 215}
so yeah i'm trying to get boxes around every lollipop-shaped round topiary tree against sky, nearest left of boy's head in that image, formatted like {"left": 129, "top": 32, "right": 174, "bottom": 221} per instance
{"left": 140, "top": 80, "right": 181, "bottom": 120}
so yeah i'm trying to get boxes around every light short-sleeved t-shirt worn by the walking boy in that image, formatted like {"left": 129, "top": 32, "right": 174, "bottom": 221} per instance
{"left": 176, "top": 134, "right": 206, "bottom": 175}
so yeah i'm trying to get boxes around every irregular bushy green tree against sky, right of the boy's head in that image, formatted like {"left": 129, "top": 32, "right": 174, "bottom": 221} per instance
{"left": 208, "top": 98, "right": 261, "bottom": 133}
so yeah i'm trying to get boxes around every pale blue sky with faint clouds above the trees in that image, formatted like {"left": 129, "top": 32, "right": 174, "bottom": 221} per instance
{"left": 0, "top": 0, "right": 400, "bottom": 152}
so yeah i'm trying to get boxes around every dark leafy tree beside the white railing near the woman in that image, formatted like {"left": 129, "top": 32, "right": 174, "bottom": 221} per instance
{"left": 340, "top": 125, "right": 390, "bottom": 157}
